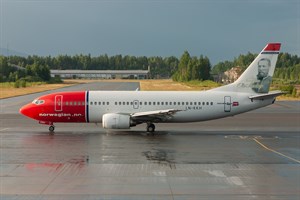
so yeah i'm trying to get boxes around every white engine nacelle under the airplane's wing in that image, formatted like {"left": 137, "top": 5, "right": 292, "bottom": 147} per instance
{"left": 102, "top": 113, "right": 130, "bottom": 129}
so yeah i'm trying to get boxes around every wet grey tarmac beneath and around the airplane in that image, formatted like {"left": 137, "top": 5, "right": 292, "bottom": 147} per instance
{"left": 0, "top": 83, "right": 300, "bottom": 200}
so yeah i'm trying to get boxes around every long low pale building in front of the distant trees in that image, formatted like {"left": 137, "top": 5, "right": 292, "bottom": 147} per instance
{"left": 50, "top": 70, "right": 150, "bottom": 79}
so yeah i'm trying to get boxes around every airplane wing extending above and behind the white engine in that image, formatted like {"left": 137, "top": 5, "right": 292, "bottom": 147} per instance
{"left": 130, "top": 109, "right": 182, "bottom": 123}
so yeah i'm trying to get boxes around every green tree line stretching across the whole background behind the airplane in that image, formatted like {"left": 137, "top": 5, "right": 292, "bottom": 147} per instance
{"left": 0, "top": 51, "right": 300, "bottom": 82}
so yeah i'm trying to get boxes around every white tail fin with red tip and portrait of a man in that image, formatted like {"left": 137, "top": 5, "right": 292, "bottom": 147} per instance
{"left": 213, "top": 43, "right": 281, "bottom": 93}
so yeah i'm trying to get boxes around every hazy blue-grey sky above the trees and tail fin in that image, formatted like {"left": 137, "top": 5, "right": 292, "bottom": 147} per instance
{"left": 0, "top": 0, "right": 300, "bottom": 64}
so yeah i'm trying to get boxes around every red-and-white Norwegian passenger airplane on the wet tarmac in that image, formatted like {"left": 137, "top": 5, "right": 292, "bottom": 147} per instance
{"left": 20, "top": 43, "right": 284, "bottom": 134}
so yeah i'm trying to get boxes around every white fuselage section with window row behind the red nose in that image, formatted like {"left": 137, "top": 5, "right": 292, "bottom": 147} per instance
{"left": 87, "top": 91, "right": 274, "bottom": 123}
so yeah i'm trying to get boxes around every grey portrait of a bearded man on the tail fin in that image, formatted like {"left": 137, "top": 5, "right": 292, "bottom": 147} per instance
{"left": 252, "top": 58, "right": 272, "bottom": 93}
